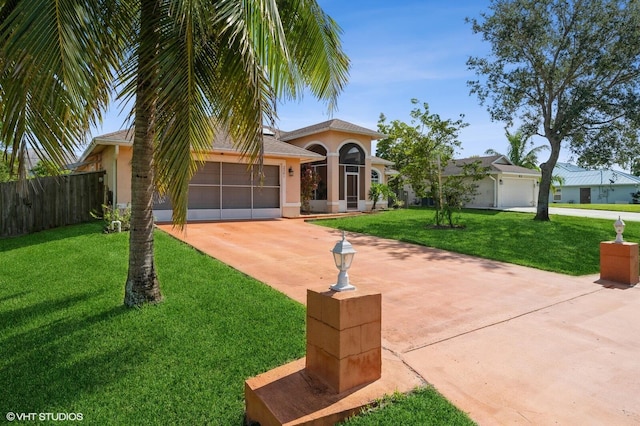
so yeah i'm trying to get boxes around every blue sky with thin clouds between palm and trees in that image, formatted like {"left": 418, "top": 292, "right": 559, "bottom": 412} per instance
{"left": 92, "top": 0, "right": 560, "bottom": 160}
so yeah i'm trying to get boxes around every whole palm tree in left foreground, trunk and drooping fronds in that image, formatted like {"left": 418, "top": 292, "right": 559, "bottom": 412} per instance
{"left": 0, "top": 0, "right": 349, "bottom": 306}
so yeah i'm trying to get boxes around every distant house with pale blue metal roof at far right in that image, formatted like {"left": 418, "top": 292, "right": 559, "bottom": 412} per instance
{"left": 549, "top": 163, "right": 640, "bottom": 204}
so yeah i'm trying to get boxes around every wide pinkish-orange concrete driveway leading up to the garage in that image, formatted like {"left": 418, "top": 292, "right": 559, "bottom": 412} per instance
{"left": 160, "top": 219, "right": 640, "bottom": 425}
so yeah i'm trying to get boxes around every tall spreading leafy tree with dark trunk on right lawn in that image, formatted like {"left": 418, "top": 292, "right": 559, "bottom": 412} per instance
{"left": 467, "top": 0, "right": 640, "bottom": 220}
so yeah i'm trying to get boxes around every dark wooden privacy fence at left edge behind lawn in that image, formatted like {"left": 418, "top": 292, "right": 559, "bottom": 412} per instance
{"left": 0, "top": 171, "right": 105, "bottom": 238}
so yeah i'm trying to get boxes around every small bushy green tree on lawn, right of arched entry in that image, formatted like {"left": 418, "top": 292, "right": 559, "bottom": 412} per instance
{"left": 376, "top": 99, "right": 482, "bottom": 226}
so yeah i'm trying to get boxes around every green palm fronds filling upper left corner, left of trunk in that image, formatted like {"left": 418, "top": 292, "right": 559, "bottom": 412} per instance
{"left": 0, "top": 0, "right": 131, "bottom": 173}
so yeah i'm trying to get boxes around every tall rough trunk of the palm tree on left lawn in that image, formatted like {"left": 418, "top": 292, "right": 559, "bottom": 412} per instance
{"left": 124, "top": 0, "right": 162, "bottom": 306}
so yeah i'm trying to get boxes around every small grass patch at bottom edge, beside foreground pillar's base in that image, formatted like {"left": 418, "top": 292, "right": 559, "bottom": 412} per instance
{"left": 342, "top": 387, "right": 475, "bottom": 426}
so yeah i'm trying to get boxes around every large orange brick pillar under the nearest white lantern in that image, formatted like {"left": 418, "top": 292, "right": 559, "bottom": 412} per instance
{"left": 305, "top": 288, "right": 382, "bottom": 393}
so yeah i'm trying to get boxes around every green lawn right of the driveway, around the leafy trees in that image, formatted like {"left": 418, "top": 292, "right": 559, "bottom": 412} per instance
{"left": 316, "top": 208, "right": 640, "bottom": 275}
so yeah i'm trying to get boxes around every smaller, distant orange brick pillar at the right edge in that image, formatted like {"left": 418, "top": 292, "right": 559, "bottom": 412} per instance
{"left": 600, "top": 241, "right": 639, "bottom": 285}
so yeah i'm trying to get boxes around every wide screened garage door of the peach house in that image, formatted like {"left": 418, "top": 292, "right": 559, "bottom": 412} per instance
{"left": 154, "top": 162, "right": 282, "bottom": 221}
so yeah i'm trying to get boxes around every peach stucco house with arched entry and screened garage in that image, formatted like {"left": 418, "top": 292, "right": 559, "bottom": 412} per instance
{"left": 76, "top": 119, "right": 390, "bottom": 221}
